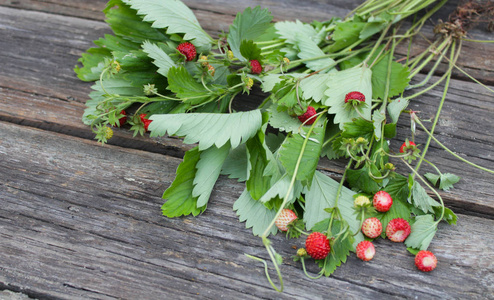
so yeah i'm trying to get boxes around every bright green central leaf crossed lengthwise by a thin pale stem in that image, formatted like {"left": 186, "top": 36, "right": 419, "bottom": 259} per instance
{"left": 279, "top": 122, "right": 326, "bottom": 182}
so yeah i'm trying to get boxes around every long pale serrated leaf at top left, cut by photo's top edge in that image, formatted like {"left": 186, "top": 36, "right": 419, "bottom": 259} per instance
{"left": 124, "top": 0, "right": 213, "bottom": 52}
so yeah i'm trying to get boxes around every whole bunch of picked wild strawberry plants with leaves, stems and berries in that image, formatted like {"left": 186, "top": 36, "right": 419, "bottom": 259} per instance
{"left": 75, "top": 0, "right": 494, "bottom": 291}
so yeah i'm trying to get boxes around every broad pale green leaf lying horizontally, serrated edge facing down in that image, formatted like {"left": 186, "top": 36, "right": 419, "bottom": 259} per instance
{"left": 149, "top": 110, "right": 262, "bottom": 150}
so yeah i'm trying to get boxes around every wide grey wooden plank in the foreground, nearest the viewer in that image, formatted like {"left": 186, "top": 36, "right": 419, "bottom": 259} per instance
{"left": 0, "top": 122, "right": 494, "bottom": 299}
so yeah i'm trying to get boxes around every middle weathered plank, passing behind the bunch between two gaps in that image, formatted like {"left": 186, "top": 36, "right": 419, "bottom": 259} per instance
{"left": 0, "top": 8, "right": 494, "bottom": 215}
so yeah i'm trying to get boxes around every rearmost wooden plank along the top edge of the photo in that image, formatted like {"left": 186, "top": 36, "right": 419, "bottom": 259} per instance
{"left": 0, "top": 0, "right": 494, "bottom": 84}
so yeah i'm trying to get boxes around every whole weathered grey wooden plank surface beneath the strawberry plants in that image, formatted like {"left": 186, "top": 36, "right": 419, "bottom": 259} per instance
{"left": 0, "top": 0, "right": 494, "bottom": 299}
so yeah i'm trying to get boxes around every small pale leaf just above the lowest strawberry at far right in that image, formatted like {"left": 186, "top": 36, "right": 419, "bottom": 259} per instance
{"left": 405, "top": 215, "right": 437, "bottom": 250}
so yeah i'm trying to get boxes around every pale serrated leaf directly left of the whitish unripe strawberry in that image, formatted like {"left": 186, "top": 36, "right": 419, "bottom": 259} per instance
{"left": 233, "top": 189, "right": 277, "bottom": 236}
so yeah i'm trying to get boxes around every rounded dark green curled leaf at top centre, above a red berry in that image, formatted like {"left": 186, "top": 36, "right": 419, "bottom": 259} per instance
{"left": 227, "top": 6, "right": 273, "bottom": 61}
